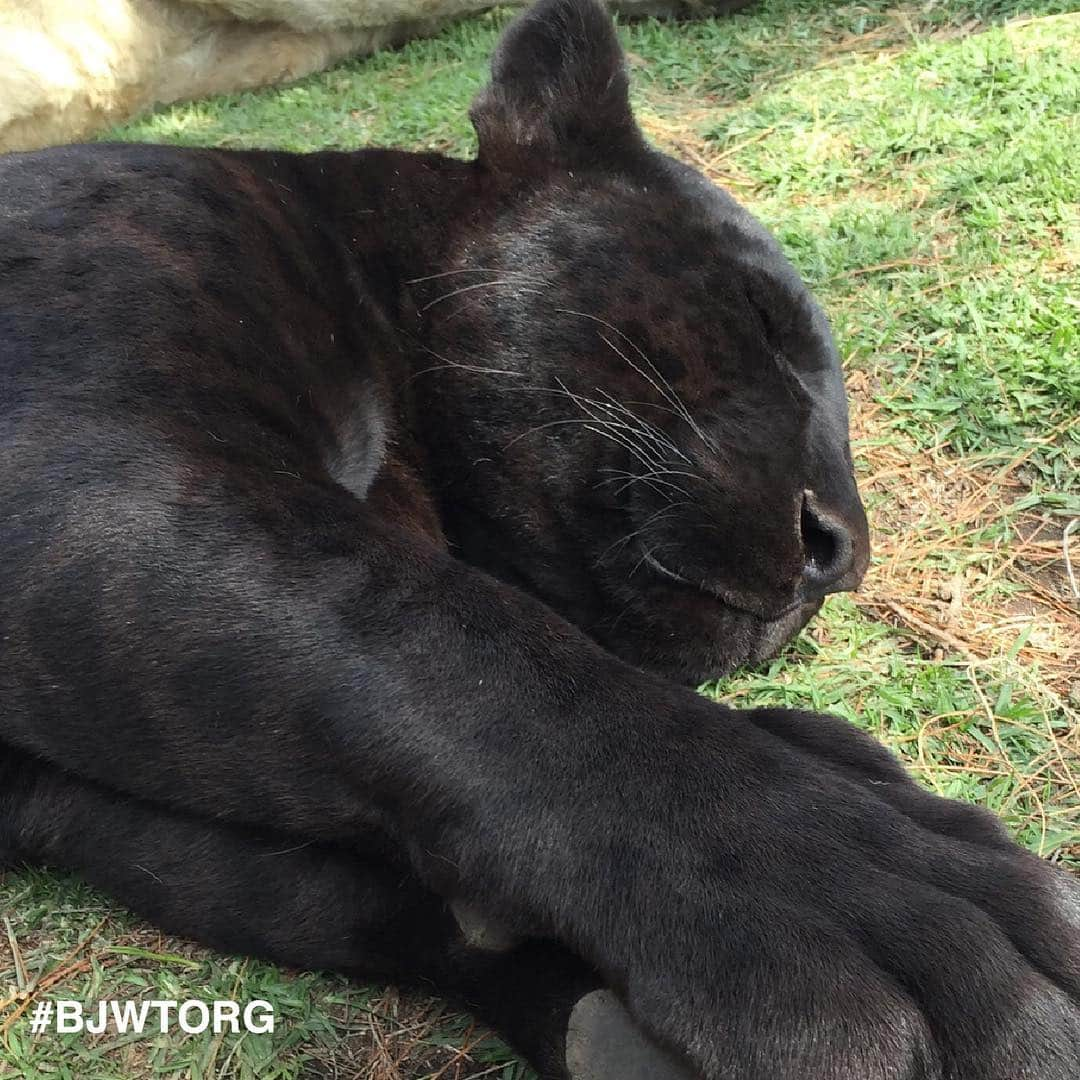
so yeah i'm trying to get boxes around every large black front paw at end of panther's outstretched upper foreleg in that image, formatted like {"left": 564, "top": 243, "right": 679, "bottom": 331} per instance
{"left": 591, "top": 713, "right": 1080, "bottom": 1080}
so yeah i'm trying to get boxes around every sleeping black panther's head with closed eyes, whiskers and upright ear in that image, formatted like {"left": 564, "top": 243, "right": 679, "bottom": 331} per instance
{"left": 415, "top": 0, "right": 868, "bottom": 681}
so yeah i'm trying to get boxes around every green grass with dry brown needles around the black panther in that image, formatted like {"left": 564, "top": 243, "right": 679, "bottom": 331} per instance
{"left": 0, "top": 0, "right": 1080, "bottom": 1080}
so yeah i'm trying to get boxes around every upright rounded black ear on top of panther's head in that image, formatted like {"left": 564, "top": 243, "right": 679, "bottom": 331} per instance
{"left": 470, "top": 0, "right": 640, "bottom": 170}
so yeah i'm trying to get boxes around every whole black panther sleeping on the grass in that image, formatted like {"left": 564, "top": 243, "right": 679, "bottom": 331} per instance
{"left": 0, "top": 0, "right": 1080, "bottom": 1080}
